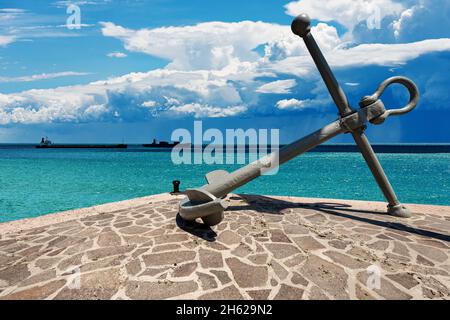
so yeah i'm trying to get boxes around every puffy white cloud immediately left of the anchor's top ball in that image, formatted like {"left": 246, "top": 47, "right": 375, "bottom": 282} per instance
{"left": 101, "top": 21, "right": 294, "bottom": 70}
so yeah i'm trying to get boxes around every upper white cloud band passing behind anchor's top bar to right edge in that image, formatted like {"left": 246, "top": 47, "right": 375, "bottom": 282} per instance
{"left": 102, "top": 17, "right": 450, "bottom": 76}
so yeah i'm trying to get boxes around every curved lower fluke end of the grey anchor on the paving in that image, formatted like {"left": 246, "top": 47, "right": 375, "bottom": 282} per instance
{"left": 179, "top": 189, "right": 228, "bottom": 226}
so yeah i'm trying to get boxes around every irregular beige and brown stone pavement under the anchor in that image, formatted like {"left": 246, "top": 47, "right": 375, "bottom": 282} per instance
{"left": 0, "top": 194, "right": 450, "bottom": 299}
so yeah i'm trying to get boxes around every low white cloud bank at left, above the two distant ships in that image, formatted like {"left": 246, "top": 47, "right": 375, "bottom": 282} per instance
{"left": 0, "top": 69, "right": 247, "bottom": 124}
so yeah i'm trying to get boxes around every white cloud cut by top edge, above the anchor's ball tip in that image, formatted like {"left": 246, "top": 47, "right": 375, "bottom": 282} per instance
{"left": 285, "top": 0, "right": 404, "bottom": 31}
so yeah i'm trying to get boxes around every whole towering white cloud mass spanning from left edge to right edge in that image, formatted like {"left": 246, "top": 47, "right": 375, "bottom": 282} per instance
{"left": 0, "top": 5, "right": 450, "bottom": 124}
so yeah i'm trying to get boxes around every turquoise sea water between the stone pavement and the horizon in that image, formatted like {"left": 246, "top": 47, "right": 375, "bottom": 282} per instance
{"left": 0, "top": 148, "right": 450, "bottom": 222}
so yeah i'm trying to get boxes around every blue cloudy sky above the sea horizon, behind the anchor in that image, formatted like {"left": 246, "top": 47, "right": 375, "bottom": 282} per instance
{"left": 0, "top": 0, "right": 450, "bottom": 143}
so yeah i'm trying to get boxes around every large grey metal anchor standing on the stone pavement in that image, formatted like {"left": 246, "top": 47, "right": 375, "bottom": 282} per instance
{"left": 179, "top": 14, "right": 419, "bottom": 226}
